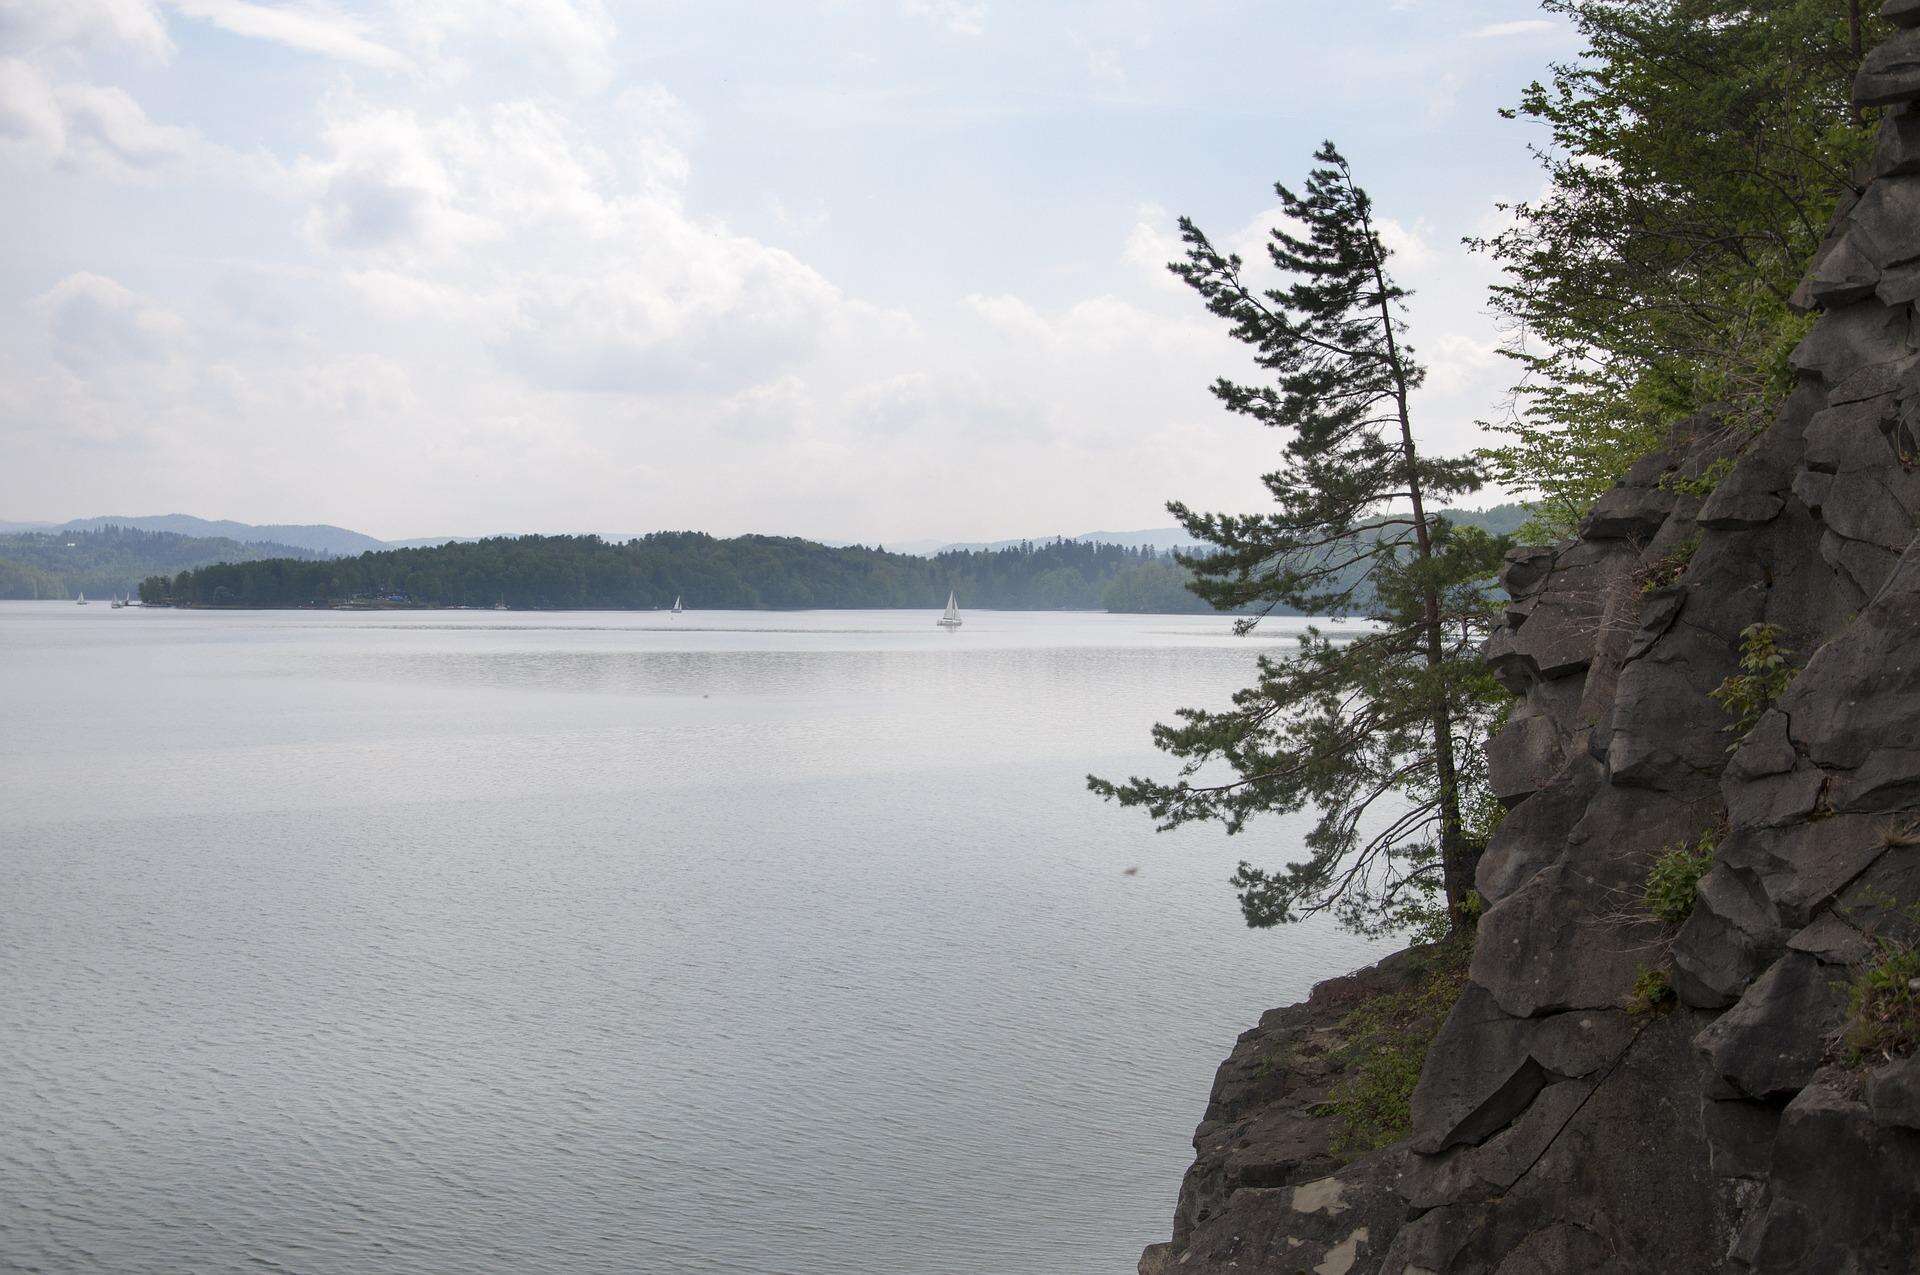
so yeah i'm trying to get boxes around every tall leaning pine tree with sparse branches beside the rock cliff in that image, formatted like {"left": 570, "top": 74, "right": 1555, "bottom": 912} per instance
{"left": 1089, "top": 142, "right": 1505, "bottom": 933}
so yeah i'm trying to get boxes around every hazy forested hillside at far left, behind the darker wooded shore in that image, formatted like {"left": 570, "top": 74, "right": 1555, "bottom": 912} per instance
{"left": 0, "top": 526, "right": 319, "bottom": 597}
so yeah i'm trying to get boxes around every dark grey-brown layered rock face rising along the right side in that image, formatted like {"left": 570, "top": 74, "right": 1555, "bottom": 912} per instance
{"left": 1140, "top": 12, "right": 1920, "bottom": 1275}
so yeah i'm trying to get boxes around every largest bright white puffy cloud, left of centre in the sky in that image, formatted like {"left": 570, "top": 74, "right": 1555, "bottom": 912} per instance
{"left": 301, "top": 90, "right": 871, "bottom": 394}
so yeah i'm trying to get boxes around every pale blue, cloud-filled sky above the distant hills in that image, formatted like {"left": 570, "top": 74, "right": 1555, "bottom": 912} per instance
{"left": 0, "top": 0, "right": 1576, "bottom": 543}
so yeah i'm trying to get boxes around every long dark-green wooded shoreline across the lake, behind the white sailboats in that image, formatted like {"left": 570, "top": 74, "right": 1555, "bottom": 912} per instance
{"left": 140, "top": 532, "right": 1228, "bottom": 611}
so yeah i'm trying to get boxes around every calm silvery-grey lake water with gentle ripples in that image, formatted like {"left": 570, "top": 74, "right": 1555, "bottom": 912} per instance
{"left": 0, "top": 603, "right": 1373, "bottom": 1275}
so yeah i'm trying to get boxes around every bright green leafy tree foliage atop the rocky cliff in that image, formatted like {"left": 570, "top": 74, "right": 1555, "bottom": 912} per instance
{"left": 1475, "top": 0, "right": 1885, "bottom": 532}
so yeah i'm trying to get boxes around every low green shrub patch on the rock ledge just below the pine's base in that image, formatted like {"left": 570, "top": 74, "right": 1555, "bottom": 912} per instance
{"left": 1315, "top": 939, "right": 1473, "bottom": 1158}
